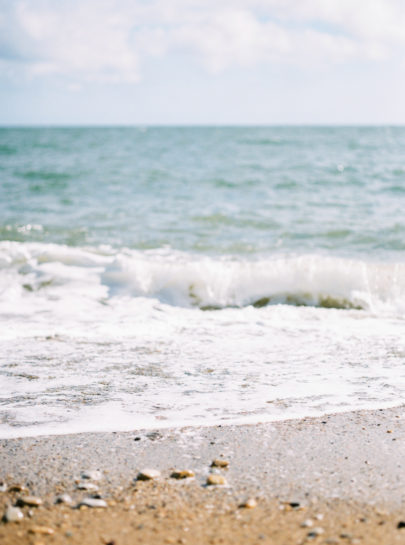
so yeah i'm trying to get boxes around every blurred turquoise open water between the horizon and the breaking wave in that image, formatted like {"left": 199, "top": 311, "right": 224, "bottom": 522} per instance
{"left": 0, "top": 127, "right": 405, "bottom": 259}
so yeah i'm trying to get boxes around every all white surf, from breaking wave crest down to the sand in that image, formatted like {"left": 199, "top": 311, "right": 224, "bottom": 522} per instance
{"left": 0, "top": 242, "right": 405, "bottom": 437}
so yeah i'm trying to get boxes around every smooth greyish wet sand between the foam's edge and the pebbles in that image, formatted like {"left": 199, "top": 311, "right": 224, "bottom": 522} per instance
{"left": 0, "top": 405, "right": 405, "bottom": 502}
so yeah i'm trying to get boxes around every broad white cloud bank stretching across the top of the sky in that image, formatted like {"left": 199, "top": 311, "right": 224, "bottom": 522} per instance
{"left": 0, "top": 0, "right": 405, "bottom": 82}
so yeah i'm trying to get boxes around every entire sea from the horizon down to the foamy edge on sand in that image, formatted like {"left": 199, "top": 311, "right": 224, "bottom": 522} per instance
{"left": 0, "top": 127, "right": 405, "bottom": 438}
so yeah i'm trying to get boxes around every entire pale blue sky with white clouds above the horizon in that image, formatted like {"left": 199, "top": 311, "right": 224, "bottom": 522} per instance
{"left": 0, "top": 0, "right": 405, "bottom": 125}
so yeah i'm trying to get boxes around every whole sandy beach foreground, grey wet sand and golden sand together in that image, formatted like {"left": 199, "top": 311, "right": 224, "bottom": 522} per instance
{"left": 0, "top": 407, "right": 405, "bottom": 545}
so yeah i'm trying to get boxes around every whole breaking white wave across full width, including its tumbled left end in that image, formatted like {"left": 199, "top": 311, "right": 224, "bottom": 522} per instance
{"left": 0, "top": 241, "right": 405, "bottom": 315}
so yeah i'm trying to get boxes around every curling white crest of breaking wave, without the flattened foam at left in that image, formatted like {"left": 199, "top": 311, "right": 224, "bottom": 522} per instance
{"left": 102, "top": 254, "right": 405, "bottom": 310}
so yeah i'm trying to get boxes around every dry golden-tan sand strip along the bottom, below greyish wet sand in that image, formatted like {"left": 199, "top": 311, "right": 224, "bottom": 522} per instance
{"left": 0, "top": 479, "right": 405, "bottom": 545}
